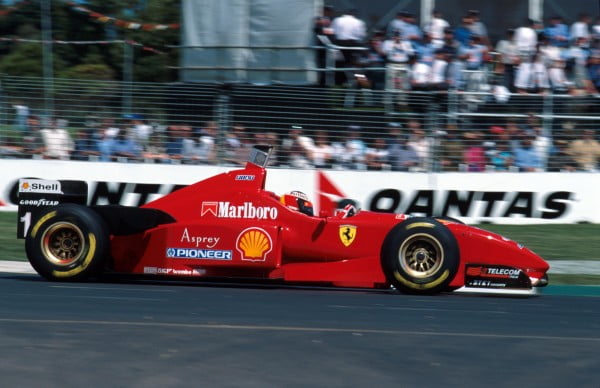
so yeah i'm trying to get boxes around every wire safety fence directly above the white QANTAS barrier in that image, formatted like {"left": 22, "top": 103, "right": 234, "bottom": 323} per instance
{"left": 0, "top": 76, "right": 600, "bottom": 171}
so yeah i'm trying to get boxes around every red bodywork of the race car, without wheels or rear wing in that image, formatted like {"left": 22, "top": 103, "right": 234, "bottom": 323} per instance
{"left": 106, "top": 159, "right": 549, "bottom": 291}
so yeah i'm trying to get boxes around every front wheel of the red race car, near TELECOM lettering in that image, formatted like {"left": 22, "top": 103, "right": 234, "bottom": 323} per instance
{"left": 381, "top": 217, "right": 460, "bottom": 294}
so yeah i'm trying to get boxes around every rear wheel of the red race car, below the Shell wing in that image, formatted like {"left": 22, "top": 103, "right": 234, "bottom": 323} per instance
{"left": 25, "top": 203, "right": 109, "bottom": 281}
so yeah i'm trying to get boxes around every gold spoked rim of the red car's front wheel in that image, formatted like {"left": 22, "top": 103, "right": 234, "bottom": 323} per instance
{"left": 398, "top": 233, "right": 444, "bottom": 279}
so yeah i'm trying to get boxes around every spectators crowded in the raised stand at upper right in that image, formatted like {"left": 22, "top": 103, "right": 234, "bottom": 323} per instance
{"left": 314, "top": 6, "right": 600, "bottom": 94}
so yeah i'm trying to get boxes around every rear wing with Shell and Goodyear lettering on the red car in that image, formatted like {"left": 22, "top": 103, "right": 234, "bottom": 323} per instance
{"left": 17, "top": 178, "right": 88, "bottom": 238}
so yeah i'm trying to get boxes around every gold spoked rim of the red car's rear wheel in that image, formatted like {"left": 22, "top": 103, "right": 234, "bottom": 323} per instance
{"left": 41, "top": 222, "right": 85, "bottom": 267}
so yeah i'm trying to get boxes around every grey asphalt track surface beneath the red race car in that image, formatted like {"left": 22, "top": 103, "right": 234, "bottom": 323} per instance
{"left": 0, "top": 273, "right": 600, "bottom": 387}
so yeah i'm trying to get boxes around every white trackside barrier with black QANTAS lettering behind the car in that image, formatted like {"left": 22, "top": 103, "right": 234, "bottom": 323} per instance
{"left": 0, "top": 160, "right": 600, "bottom": 224}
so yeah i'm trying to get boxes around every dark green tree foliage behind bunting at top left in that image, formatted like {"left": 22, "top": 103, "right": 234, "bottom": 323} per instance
{"left": 0, "top": 0, "right": 181, "bottom": 82}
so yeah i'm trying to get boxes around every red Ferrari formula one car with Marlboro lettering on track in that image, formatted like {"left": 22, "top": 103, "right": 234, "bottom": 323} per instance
{"left": 18, "top": 146, "right": 549, "bottom": 294}
